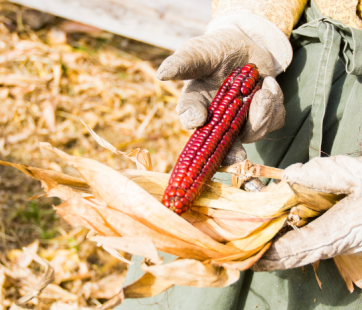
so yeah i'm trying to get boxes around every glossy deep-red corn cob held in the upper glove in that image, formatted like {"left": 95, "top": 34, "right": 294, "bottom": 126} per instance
{"left": 162, "top": 64, "right": 262, "bottom": 214}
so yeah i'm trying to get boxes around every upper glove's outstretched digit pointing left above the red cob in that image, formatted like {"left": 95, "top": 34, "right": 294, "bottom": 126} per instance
{"left": 157, "top": 29, "right": 247, "bottom": 81}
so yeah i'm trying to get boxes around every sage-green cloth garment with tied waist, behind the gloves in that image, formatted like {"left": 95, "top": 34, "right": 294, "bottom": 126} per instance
{"left": 117, "top": 2, "right": 362, "bottom": 310}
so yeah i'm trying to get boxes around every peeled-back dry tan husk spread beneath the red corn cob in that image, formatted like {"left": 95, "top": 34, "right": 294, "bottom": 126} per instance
{"left": 0, "top": 140, "right": 359, "bottom": 309}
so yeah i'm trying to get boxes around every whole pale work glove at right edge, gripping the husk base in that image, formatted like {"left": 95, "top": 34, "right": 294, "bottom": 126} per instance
{"left": 252, "top": 156, "right": 362, "bottom": 271}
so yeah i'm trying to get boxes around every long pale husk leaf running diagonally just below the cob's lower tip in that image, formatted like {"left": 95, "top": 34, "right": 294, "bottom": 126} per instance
{"left": 41, "top": 143, "right": 236, "bottom": 254}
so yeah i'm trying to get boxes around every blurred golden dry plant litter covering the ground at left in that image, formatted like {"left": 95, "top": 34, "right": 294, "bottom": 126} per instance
{"left": 0, "top": 1, "right": 190, "bottom": 309}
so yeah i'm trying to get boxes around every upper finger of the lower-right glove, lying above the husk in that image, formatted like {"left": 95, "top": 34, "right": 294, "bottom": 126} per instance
{"left": 282, "top": 155, "right": 362, "bottom": 194}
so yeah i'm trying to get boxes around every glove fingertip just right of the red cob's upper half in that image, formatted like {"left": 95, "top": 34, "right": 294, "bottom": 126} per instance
{"left": 240, "top": 76, "right": 285, "bottom": 143}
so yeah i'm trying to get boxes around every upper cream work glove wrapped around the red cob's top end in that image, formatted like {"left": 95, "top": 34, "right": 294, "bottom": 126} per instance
{"left": 157, "top": 7, "right": 292, "bottom": 164}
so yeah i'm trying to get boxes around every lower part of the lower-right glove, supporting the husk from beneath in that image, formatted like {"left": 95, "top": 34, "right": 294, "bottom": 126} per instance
{"left": 253, "top": 196, "right": 362, "bottom": 271}
